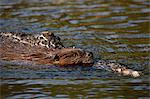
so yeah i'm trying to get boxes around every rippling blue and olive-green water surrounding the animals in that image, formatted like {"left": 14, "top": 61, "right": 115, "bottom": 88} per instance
{"left": 0, "top": 0, "right": 150, "bottom": 99}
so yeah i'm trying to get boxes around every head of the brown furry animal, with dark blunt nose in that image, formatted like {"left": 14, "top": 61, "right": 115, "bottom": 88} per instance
{"left": 54, "top": 48, "right": 93, "bottom": 66}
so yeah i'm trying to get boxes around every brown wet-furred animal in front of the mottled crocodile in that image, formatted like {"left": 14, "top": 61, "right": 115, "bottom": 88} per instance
{"left": 0, "top": 32, "right": 93, "bottom": 66}
